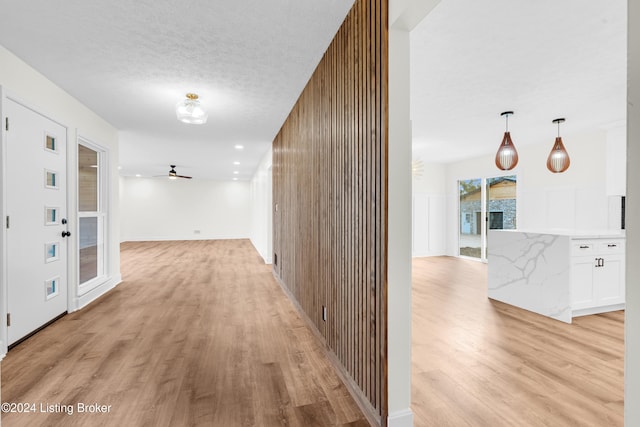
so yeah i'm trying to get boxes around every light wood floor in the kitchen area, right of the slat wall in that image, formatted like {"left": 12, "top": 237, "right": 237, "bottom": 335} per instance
{"left": 412, "top": 257, "right": 624, "bottom": 427}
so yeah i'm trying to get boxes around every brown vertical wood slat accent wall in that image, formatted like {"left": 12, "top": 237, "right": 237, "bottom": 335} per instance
{"left": 273, "top": 0, "right": 388, "bottom": 421}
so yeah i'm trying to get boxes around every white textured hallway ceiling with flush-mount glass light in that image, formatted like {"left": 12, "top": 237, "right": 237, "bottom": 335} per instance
{"left": 0, "top": 0, "right": 353, "bottom": 180}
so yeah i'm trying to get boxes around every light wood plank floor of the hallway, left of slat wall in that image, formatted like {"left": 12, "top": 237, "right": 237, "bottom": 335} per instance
{"left": 2, "top": 240, "right": 368, "bottom": 427}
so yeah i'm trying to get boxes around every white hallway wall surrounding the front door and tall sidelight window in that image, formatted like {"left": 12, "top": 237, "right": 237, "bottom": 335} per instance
{"left": 0, "top": 46, "right": 121, "bottom": 320}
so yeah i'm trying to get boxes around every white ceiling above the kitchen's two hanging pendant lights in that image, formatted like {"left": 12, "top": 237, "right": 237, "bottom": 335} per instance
{"left": 411, "top": 0, "right": 627, "bottom": 162}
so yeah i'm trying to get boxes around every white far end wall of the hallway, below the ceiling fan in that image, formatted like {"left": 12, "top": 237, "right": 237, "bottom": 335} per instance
{"left": 120, "top": 178, "right": 250, "bottom": 241}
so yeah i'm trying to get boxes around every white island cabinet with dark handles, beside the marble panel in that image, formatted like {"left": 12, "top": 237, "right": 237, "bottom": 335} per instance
{"left": 571, "top": 239, "right": 625, "bottom": 317}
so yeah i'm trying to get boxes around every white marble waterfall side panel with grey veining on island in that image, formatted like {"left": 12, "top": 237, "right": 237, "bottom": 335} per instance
{"left": 488, "top": 231, "right": 571, "bottom": 323}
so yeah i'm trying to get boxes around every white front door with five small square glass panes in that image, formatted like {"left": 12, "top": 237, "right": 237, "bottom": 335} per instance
{"left": 3, "top": 99, "right": 69, "bottom": 345}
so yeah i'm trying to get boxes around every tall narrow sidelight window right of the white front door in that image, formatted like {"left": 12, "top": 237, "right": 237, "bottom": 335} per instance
{"left": 78, "top": 139, "right": 106, "bottom": 295}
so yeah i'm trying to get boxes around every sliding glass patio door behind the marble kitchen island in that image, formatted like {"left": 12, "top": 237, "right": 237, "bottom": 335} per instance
{"left": 458, "top": 175, "right": 516, "bottom": 260}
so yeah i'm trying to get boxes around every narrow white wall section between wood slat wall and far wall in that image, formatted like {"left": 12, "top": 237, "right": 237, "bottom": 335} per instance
{"left": 251, "top": 149, "right": 273, "bottom": 264}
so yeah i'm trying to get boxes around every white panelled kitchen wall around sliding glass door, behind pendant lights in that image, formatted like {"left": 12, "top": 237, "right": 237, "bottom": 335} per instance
{"left": 446, "top": 131, "right": 619, "bottom": 255}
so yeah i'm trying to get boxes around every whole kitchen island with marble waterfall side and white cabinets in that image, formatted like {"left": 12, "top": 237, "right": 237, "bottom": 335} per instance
{"left": 487, "top": 230, "right": 624, "bottom": 323}
